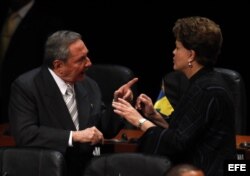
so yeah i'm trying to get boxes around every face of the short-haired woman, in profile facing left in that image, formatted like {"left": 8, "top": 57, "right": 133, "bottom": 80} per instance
{"left": 173, "top": 40, "right": 193, "bottom": 73}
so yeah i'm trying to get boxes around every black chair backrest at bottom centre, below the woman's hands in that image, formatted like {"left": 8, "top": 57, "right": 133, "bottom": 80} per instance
{"left": 84, "top": 153, "right": 171, "bottom": 176}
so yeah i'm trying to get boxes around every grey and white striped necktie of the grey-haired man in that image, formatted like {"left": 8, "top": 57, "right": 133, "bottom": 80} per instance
{"left": 65, "top": 84, "right": 79, "bottom": 130}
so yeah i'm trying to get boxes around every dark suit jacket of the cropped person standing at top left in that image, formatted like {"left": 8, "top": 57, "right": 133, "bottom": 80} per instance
{"left": 0, "top": 2, "right": 64, "bottom": 122}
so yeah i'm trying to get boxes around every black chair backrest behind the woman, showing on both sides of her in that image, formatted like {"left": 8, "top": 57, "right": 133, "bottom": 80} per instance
{"left": 163, "top": 67, "right": 247, "bottom": 135}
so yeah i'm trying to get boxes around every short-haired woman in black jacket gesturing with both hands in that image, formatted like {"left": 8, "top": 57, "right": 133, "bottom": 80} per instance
{"left": 113, "top": 17, "right": 236, "bottom": 176}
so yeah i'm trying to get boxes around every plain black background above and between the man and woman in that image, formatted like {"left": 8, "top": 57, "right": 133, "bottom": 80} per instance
{"left": 2, "top": 0, "right": 250, "bottom": 134}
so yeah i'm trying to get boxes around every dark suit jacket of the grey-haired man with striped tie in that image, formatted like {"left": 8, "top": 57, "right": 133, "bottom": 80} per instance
{"left": 9, "top": 67, "right": 123, "bottom": 175}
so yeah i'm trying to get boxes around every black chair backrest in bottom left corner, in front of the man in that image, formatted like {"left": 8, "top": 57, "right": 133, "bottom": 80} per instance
{"left": 0, "top": 147, "right": 66, "bottom": 176}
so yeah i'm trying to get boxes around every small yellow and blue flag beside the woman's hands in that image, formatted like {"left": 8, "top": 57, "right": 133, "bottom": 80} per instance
{"left": 154, "top": 84, "right": 174, "bottom": 116}
